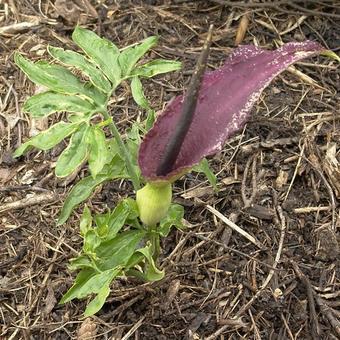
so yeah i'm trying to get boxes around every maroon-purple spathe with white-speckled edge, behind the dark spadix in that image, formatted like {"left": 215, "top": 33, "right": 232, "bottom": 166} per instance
{"left": 138, "top": 41, "right": 325, "bottom": 181}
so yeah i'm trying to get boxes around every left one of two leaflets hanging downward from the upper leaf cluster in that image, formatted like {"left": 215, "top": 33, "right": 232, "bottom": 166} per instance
{"left": 55, "top": 124, "right": 89, "bottom": 177}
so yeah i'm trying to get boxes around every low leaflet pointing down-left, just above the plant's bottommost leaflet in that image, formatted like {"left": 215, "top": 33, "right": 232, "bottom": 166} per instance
{"left": 60, "top": 268, "right": 121, "bottom": 303}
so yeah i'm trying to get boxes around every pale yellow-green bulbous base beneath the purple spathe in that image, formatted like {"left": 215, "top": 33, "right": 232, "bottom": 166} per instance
{"left": 136, "top": 182, "right": 172, "bottom": 226}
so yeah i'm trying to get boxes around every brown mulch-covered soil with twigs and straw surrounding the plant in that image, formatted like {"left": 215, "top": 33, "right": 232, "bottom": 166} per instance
{"left": 0, "top": 0, "right": 340, "bottom": 339}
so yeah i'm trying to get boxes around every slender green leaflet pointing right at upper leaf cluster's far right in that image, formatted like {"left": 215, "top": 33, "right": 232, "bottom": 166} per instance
{"left": 131, "top": 59, "right": 182, "bottom": 78}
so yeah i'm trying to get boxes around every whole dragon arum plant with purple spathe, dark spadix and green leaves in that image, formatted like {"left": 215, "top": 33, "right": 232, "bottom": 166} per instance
{"left": 15, "top": 27, "right": 338, "bottom": 316}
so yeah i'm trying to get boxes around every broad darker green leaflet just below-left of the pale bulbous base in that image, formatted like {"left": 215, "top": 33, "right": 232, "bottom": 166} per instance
{"left": 96, "top": 230, "right": 145, "bottom": 270}
